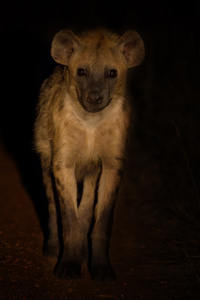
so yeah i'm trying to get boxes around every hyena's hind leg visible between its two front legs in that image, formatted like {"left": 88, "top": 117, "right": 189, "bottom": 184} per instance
{"left": 78, "top": 169, "right": 100, "bottom": 262}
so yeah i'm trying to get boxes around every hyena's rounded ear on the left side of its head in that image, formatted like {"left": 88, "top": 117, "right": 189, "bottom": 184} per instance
{"left": 51, "top": 29, "right": 80, "bottom": 65}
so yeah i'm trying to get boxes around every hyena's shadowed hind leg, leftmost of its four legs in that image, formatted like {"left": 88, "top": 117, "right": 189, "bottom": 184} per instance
{"left": 42, "top": 159, "right": 60, "bottom": 257}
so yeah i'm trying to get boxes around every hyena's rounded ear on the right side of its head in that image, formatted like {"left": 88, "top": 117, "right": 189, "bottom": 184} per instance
{"left": 118, "top": 30, "right": 145, "bottom": 68}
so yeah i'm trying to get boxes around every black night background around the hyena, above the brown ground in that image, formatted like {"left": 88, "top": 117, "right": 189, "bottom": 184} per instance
{"left": 0, "top": 0, "right": 200, "bottom": 233}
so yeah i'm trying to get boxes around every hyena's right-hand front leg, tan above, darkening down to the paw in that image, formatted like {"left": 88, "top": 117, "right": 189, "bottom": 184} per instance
{"left": 91, "top": 165, "right": 122, "bottom": 280}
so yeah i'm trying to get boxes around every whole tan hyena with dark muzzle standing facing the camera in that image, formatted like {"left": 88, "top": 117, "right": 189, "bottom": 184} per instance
{"left": 35, "top": 30, "right": 144, "bottom": 280}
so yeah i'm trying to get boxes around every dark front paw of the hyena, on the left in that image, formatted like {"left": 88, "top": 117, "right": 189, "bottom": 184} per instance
{"left": 54, "top": 262, "right": 81, "bottom": 279}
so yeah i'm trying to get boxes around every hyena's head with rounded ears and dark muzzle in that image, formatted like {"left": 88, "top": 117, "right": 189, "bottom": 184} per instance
{"left": 51, "top": 30, "right": 145, "bottom": 112}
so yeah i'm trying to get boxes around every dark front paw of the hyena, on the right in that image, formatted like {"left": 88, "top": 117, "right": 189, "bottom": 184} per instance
{"left": 91, "top": 265, "right": 116, "bottom": 281}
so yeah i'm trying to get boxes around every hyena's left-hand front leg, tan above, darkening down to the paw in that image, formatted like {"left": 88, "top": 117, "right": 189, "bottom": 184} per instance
{"left": 53, "top": 164, "right": 82, "bottom": 279}
